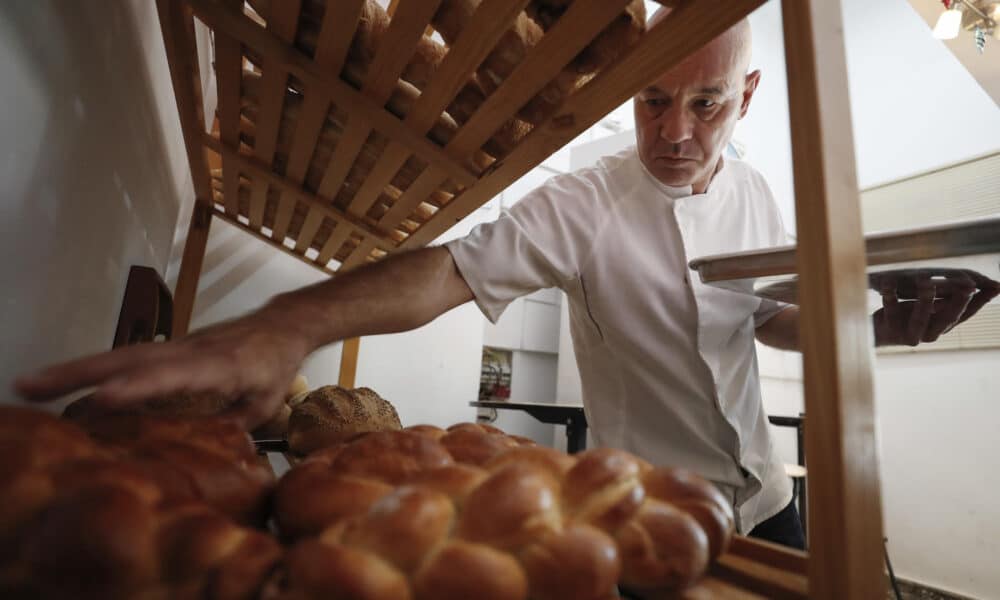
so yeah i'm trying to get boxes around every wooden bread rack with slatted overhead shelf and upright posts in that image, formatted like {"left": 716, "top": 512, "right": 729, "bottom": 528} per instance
{"left": 157, "top": 0, "right": 886, "bottom": 600}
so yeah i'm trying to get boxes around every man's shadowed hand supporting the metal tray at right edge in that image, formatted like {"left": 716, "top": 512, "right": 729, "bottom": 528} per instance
{"left": 870, "top": 269, "right": 1000, "bottom": 346}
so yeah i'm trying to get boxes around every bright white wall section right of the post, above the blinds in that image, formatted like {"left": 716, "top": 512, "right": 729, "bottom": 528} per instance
{"left": 842, "top": 0, "right": 1000, "bottom": 188}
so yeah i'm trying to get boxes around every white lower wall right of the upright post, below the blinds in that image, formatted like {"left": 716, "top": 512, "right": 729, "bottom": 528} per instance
{"left": 875, "top": 350, "right": 1000, "bottom": 598}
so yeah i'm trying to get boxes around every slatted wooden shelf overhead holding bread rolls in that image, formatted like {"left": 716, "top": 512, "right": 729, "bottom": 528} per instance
{"left": 161, "top": 0, "right": 762, "bottom": 274}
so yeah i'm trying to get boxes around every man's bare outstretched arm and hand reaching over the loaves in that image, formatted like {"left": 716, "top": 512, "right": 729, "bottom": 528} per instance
{"left": 14, "top": 248, "right": 473, "bottom": 428}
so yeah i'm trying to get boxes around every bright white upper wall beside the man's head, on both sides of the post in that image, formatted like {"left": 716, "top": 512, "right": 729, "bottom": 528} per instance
{"left": 735, "top": 0, "right": 1000, "bottom": 232}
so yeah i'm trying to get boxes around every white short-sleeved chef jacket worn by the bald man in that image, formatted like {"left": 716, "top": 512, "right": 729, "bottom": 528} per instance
{"left": 446, "top": 147, "right": 792, "bottom": 533}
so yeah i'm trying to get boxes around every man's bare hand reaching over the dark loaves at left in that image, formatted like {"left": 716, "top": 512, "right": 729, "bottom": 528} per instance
{"left": 14, "top": 306, "right": 312, "bottom": 430}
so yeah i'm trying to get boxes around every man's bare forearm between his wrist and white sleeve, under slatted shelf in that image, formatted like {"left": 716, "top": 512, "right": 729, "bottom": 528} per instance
{"left": 262, "top": 247, "right": 473, "bottom": 349}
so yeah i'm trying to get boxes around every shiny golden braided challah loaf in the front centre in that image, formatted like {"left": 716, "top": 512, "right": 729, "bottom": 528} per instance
{"left": 275, "top": 424, "right": 733, "bottom": 600}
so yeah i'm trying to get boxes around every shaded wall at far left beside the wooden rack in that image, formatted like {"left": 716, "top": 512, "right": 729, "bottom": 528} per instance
{"left": 0, "top": 0, "right": 192, "bottom": 408}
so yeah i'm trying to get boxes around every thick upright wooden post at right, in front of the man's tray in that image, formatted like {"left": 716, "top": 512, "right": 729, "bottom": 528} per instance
{"left": 781, "top": 0, "right": 888, "bottom": 600}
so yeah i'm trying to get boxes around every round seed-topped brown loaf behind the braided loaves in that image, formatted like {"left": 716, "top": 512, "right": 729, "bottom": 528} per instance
{"left": 288, "top": 385, "right": 401, "bottom": 454}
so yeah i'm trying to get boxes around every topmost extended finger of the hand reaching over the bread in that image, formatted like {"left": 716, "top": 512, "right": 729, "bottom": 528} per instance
{"left": 14, "top": 343, "right": 184, "bottom": 402}
